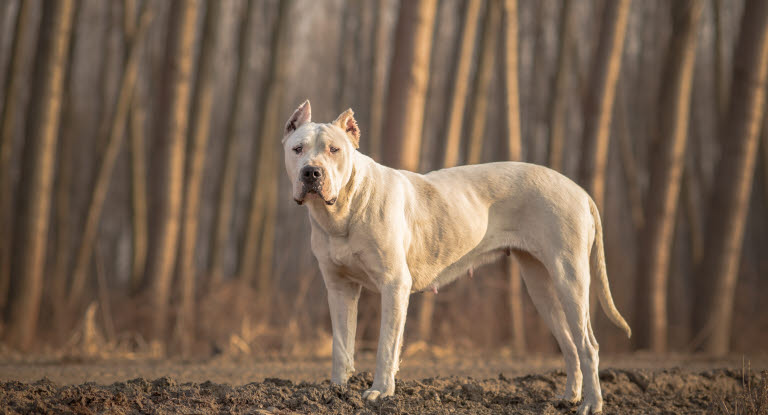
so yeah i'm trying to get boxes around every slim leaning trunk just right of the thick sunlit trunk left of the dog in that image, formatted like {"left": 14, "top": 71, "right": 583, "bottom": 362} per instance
{"left": 175, "top": 1, "right": 221, "bottom": 356}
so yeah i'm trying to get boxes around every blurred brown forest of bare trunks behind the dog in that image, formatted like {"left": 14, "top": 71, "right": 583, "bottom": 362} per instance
{"left": 0, "top": 0, "right": 768, "bottom": 357}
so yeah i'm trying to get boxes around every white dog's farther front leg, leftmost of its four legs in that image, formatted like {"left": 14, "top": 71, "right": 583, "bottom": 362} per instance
{"left": 323, "top": 270, "right": 360, "bottom": 385}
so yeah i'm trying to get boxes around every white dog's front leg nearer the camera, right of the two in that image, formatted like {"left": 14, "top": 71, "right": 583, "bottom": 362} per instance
{"left": 363, "top": 274, "right": 411, "bottom": 400}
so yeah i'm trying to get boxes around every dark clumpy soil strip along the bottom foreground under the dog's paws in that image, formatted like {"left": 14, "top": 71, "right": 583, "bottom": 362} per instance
{"left": 0, "top": 369, "right": 756, "bottom": 414}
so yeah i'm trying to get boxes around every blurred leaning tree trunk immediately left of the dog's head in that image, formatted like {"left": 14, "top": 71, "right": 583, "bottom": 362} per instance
{"left": 238, "top": 0, "right": 293, "bottom": 300}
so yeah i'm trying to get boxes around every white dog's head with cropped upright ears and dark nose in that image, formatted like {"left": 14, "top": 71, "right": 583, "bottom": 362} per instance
{"left": 283, "top": 101, "right": 360, "bottom": 205}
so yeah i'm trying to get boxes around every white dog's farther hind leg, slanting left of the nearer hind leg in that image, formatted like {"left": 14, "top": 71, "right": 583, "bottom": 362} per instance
{"left": 515, "top": 251, "right": 582, "bottom": 402}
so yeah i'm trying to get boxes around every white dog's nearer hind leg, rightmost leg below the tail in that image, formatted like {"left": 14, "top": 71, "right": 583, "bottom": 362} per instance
{"left": 552, "top": 252, "right": 603, "bottom": 414}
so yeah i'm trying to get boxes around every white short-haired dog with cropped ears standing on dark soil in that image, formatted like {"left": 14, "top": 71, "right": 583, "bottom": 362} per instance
{"left": 283, "top": 101, "right": 630, "bottom": 413}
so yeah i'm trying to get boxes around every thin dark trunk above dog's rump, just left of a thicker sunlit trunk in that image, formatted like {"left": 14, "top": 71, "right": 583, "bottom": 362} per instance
{"left": 549, "top": 0, "right": 573, "bottom": 171}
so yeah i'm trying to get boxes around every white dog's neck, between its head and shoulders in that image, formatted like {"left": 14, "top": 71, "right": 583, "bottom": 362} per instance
{"left": 306, "top": 151, "right": 371, "bottom": 237}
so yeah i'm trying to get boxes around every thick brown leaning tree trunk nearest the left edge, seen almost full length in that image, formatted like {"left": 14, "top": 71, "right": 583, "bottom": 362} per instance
{"left": 3, "top": 0, "right": 75, "bottom": 349}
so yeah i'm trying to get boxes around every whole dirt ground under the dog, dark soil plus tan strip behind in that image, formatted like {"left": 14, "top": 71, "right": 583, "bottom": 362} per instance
{"left": 0, "top": 354, "right": 768, "bottom": 414}
